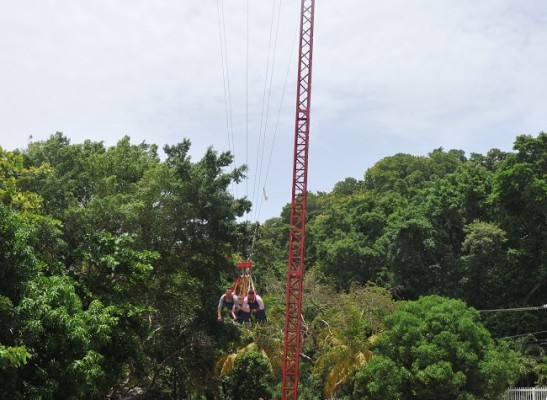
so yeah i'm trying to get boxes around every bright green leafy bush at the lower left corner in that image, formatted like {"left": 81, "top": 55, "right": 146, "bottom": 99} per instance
{"left": 15, "top": 276, "right": 116, "bottom": 399}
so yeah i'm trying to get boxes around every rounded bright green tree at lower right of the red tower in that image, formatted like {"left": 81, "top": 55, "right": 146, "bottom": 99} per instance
{"left": 354, "top": 296, "right": 518, "bottom": 400}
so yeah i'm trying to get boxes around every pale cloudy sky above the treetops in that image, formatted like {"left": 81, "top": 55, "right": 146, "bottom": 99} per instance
{"left": 0, "top": 0, "right": 547, "bottom": 221}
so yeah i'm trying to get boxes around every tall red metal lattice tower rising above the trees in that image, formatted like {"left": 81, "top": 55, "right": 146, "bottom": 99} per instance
{"left": 281, "top": 0, "right": 315, "bottom": 400}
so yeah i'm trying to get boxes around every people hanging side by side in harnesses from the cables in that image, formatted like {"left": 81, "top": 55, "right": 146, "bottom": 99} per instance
{"left": 217, "top": 287, "right": 266, "bottom": 325}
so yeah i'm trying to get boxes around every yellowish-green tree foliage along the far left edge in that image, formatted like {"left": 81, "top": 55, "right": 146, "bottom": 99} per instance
{"left": 0, "top": 148, "right": 56, "bottom": 390}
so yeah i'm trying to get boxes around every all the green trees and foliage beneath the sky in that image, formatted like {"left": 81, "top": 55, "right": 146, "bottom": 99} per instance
{"left": 0, "top": 132, "right": 547, "bottom": 399}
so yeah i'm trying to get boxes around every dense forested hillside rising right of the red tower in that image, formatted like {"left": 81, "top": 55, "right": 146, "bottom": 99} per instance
{"left": 296, "top": 133, "right": 547, "bottom": 336}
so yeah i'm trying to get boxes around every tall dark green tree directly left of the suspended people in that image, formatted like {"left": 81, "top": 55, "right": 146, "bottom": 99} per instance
{"left": 139, "top": 140, "right": 253, "bottom": 397}
